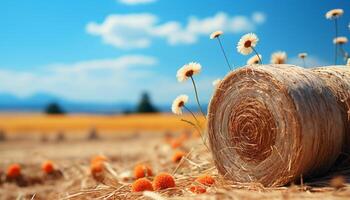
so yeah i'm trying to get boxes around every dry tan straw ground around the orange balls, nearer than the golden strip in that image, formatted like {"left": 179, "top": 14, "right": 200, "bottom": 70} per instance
{"left": 0, "top": 113, "right": 350, "bottom": 200}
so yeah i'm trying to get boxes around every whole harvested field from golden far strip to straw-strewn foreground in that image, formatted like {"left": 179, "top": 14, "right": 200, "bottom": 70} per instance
{"left": 0, "top": 114, "right": 350, "bottom": 199}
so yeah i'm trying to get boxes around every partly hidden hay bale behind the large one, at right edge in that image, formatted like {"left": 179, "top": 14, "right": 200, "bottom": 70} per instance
{"left": 312, "top": 65, "right": 350, "bottom": 161}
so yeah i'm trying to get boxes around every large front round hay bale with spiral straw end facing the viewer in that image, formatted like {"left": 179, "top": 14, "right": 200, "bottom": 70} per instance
{"left": 207, "top": 65, "right": 344, "bottom": 186}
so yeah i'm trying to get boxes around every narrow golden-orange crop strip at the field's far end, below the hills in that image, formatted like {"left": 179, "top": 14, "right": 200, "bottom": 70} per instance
{"left": 0, "top": 113, "right": 203, "bottom": 133}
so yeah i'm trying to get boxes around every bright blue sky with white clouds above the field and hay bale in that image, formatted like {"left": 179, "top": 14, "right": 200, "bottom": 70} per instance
{"left": 0, "top": 0, "right": 350, "bottom": 104}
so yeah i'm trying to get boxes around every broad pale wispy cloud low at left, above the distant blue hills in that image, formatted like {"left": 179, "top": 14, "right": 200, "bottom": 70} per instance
{"left": 0, "top": 55, "right": 157, "bottom": 102}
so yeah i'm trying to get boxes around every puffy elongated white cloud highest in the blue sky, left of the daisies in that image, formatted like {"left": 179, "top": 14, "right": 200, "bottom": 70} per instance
{"left": 86, "top": 12, "right": 266, "bottom": 49}
